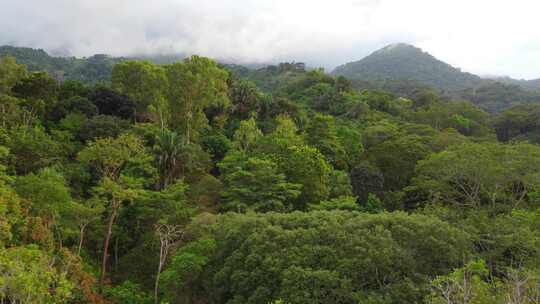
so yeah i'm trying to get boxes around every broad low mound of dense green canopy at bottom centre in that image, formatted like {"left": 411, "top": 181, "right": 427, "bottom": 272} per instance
{"left": 167, "top": 211, "right": 470, "bottom": 303}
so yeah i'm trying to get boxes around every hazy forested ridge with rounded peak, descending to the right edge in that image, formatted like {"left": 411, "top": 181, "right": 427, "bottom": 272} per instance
{"left": 332, "top": 43, "right": 540, "bottom": 113}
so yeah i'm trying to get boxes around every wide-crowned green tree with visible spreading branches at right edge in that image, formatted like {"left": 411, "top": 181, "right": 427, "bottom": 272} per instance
{"left": 410, "top": 143, "right": 540, "bottom": 209}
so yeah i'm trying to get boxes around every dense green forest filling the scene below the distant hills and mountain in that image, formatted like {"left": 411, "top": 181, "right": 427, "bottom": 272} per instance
{"left": 0, "top": 50, "right": 540, "bottom": 304}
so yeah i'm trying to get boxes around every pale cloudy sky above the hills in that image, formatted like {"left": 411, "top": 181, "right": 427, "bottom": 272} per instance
{"left": 0, "top": 0, "right": 540, "bottom": 79}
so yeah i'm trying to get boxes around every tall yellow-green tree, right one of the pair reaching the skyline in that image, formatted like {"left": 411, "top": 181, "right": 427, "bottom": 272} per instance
{"left": 166, "top": 56, "right": 229, "bottom": 144}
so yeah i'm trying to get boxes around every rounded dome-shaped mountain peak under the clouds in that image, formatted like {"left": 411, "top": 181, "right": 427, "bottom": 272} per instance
{"left": 332, "top": 43, "right": 483, "bottom": 91}
